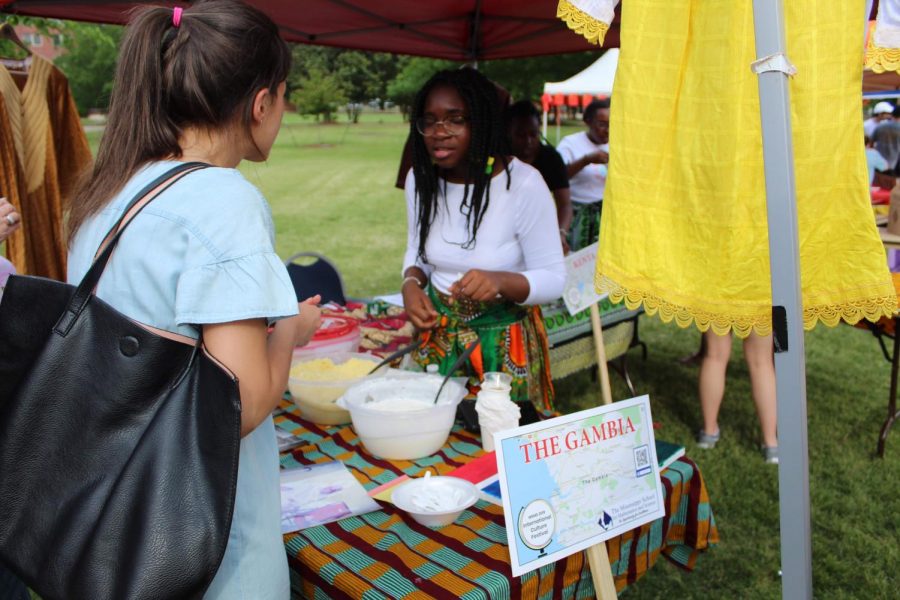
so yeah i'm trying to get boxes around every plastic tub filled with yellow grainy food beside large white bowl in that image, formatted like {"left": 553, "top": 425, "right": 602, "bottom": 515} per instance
{"left": 288, "top": 352, "right": 385, "bottom": 425}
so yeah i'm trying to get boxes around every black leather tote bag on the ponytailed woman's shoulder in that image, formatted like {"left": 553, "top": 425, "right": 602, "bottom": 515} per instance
{"left": 0, "top": 163, "right": 241, "bottom": 600}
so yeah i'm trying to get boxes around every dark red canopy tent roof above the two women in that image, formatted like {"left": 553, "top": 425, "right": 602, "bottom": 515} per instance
{"left": 0, "top": 0, "right": 619, "bottom": 61}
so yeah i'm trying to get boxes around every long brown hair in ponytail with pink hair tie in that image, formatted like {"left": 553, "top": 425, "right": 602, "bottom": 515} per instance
{"left": 68, "top": 0, "right": 291, "bottom": 244}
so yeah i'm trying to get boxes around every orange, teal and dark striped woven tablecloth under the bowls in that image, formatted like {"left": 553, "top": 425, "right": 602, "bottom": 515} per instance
{"left": 275, "top": 403, "right": 719, "bottom": 600}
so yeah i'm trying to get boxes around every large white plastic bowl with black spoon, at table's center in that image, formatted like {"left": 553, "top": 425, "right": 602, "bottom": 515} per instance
{"left": 338, "top": 374, "right": 466, "bottom": 460}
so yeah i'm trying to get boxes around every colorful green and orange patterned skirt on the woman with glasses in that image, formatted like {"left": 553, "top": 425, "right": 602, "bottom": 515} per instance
{"left": 414, "top": 285, "right": 553, "bottom": 410}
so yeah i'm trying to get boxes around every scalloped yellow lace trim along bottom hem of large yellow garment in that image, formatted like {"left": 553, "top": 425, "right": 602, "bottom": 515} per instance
{"left": 594, "top": 273, "right": 897, "bottom": 338}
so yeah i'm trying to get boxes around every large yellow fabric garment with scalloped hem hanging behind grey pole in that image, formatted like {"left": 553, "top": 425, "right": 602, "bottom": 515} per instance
{"left": 559, "top": 0, "right": 897, "bottom": 337}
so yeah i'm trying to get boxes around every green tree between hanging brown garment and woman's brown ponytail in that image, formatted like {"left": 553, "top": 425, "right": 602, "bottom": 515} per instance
{"left": 56, "top": 22, "right": 123, "bottom": 115}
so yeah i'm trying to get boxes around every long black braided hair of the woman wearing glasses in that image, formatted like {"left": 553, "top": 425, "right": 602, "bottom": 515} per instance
{"left": 409, "top": 67, "right": 511, "bottom": 262}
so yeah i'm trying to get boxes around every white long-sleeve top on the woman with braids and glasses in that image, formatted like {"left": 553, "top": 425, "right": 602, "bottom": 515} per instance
{"left": 403, "top": 158, "right": 566, "bottom": 304}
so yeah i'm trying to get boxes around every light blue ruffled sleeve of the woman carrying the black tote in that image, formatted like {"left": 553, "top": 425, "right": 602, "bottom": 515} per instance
{"left": 175, "top": 252, "right": 297, "bottom": 325}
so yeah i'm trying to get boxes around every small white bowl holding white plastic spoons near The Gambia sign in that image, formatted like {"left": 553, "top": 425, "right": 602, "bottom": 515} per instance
{"left": 391, "top": 476, "right": 478, "bottom": 527}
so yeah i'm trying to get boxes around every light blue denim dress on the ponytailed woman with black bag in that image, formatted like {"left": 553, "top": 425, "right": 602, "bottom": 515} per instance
{"left": 68, "top": 162, "right": 297, "bottom": 600}
